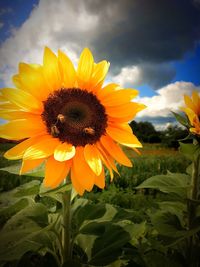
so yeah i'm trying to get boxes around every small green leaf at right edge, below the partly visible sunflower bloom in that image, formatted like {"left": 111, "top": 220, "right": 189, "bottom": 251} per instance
{"left": 179, "top": 142, "right": 200, "bottom": 161}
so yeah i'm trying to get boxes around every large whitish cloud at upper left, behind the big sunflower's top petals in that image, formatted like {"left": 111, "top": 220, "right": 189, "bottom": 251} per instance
{"left": 0, "top": 0, "right": 98, "bottom": 85}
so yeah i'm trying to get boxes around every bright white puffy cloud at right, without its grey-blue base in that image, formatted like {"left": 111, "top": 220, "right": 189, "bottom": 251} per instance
{"left": 137, "top": 82, "right": 200, "bottom": 118}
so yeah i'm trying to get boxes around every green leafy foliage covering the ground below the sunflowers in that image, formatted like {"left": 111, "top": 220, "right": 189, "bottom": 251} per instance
{"left": 0, "top": 143, "right": 200, "bottom": 267}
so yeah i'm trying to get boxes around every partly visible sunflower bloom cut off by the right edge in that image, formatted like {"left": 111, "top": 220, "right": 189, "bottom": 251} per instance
{"left": 182, "top": 91, "right": 200, "bottom": 135}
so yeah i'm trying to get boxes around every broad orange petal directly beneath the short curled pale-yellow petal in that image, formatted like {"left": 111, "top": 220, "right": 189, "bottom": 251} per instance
{"left": 44, "top": 156, "right": 71, "bottom": 188}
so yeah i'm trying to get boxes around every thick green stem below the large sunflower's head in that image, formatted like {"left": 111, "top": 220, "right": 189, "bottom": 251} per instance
{"left": 62, "top": 181, "right": 71, "bottom": 263}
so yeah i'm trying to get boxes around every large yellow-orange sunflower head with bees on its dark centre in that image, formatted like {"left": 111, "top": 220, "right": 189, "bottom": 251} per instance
{"left": 0, "top": 48, "right": 145, "bottom": 195}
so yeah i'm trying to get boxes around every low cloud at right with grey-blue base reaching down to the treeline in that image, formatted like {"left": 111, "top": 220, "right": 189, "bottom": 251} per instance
{"left": 133, "top": 82, "right": 200, "bottom": 130}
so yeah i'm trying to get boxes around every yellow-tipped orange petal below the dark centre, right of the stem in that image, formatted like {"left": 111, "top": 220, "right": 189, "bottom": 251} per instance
{"left": 84, "top": 145, "right": 102, "bottom": 176}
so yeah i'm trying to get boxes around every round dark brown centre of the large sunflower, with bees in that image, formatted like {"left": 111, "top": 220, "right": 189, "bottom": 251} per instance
{"left": 42, "top": 88, "right": 107, "bottom": 146}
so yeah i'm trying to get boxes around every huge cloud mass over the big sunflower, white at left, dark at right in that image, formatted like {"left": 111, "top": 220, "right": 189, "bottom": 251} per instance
{"left": 0, "top": 0, "right": 200, "bottom": 88}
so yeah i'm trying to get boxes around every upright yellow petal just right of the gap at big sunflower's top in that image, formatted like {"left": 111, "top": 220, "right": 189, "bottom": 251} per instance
{"left": 77, "top": 48, "right": 94, "bottom": 89}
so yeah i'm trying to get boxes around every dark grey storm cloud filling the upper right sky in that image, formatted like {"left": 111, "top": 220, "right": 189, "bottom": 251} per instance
{"left": 85, "top": 0, "right": 200, "bottom": 67}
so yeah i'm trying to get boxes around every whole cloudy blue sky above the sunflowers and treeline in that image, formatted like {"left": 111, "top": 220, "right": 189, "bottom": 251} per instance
{"left": 0, "top": 0, "right": 200, "bottom": 129}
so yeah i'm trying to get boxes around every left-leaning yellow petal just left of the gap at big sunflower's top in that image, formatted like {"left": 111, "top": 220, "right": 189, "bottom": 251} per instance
{"left": 58, "top": 50, "right": 76, "bottom": 88}
